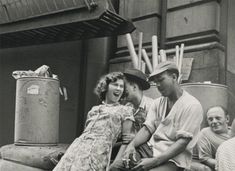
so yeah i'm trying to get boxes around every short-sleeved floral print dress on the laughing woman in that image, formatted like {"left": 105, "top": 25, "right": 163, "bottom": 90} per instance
{"left": 53, "top": 103, "right": 134, "bottom": 171}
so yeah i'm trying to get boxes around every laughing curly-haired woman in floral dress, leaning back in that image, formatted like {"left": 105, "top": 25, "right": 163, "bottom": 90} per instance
{"left": 53, "top": 72, "right": 134, "bottom": 171}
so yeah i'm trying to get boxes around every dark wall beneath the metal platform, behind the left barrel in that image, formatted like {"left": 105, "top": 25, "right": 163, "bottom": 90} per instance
{"left": 0, "top": 38, "right": 112, "bottom": 146}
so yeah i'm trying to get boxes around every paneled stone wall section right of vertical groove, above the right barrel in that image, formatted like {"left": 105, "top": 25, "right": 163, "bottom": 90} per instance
{"left": 166, "top": 0, "right": 225, "bottom": 84}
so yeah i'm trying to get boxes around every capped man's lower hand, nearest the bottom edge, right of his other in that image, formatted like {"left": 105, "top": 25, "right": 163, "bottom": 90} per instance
{"left": 131, "top": 158, "right": 159, "bottom": 171}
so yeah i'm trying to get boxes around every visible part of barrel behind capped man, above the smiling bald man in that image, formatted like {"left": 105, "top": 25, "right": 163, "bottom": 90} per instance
{"left": 181, "top": 83, "right": 228, "bottom": 128}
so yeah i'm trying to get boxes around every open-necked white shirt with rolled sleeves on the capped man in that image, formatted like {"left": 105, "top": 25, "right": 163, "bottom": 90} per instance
{"left": 144, "top": 91, "right": 203, "bottom": 169}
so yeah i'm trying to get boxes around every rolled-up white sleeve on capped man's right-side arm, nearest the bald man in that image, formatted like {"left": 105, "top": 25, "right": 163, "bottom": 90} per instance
{"left": 176, "top": 104, "right": 203, "bottom": 139}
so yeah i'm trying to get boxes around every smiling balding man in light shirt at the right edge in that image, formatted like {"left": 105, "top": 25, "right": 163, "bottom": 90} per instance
{"left": 197, "top": 106, "right": 230, "bottom": 169}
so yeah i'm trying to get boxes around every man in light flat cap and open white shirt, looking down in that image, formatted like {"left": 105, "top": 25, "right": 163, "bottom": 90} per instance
{"left": 120, "top": 61, "right": 203, "bottom": 171}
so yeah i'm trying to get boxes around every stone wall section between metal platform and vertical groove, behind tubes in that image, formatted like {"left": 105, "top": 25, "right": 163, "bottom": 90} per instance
{"left": 110, "top": 0, "right": 161, "bottom": 71}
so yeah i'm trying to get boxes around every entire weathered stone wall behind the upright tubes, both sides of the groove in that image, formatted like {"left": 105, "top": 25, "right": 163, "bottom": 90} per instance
{"left": 110, "top": 0, "right": 226, "bottom": 84}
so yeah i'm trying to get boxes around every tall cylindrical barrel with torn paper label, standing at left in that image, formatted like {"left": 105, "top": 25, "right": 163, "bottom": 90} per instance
{"left": 14, "top": 77, "right": 59, "bottom": 145}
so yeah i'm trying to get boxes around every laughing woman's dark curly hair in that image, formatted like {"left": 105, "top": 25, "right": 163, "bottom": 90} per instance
{"left": 94, "top": 72, "right": 124, "bottom": 101}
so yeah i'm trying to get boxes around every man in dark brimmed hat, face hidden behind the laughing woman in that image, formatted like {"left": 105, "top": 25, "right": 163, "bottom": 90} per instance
{"left": 110, "top": 69, "right": 153, "bottom": 170}
